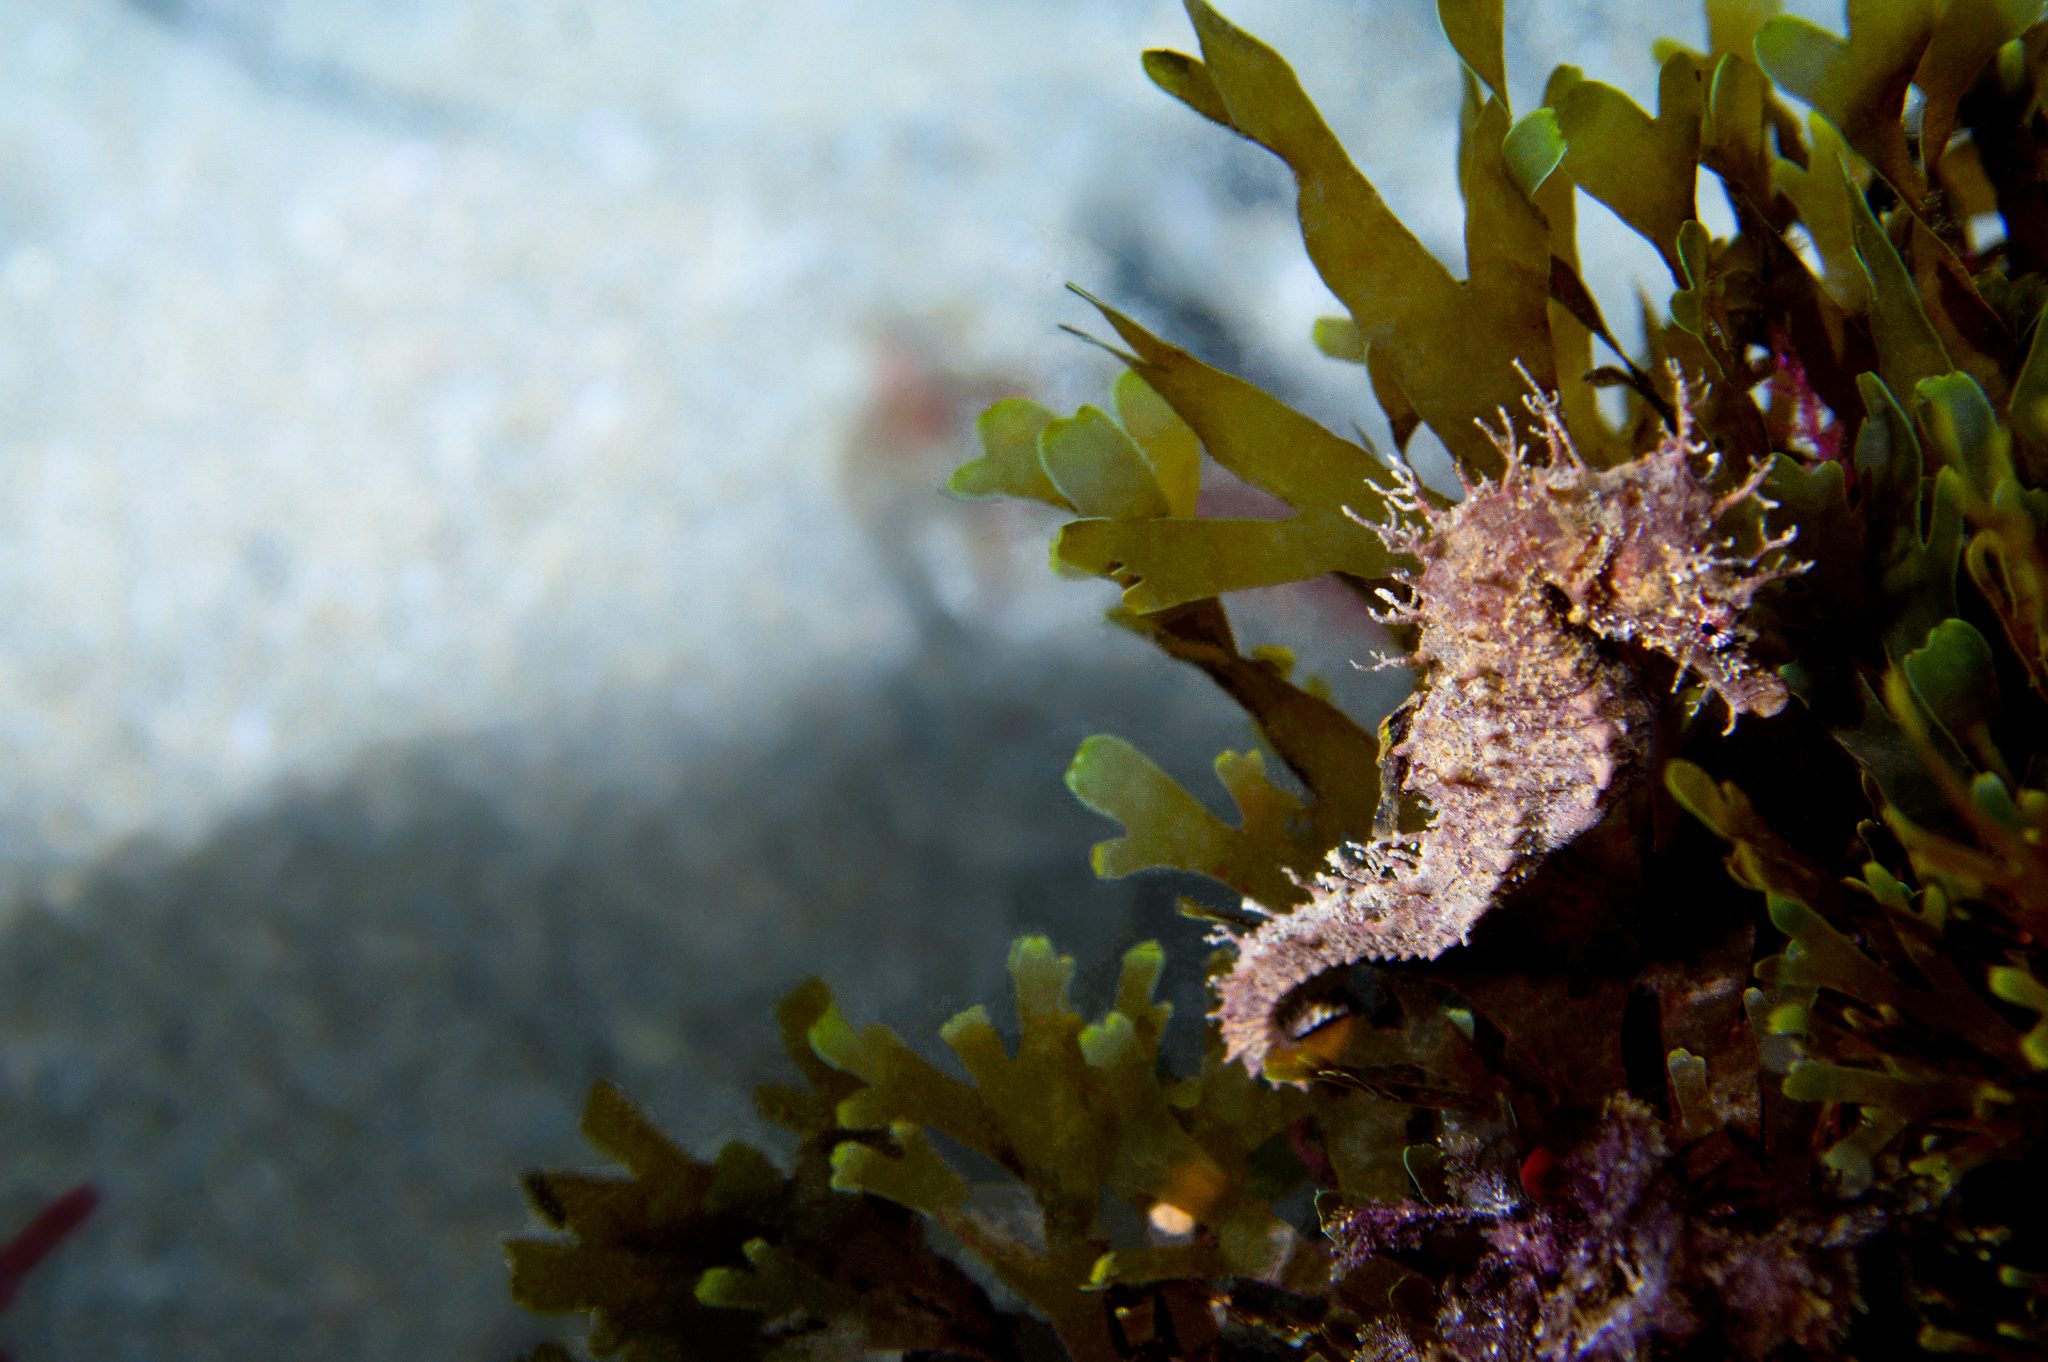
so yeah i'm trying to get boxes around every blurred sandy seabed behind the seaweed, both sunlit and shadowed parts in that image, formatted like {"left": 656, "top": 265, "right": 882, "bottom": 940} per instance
{"left": 0, "top": 0, "right": 1839, "bottom": 1362}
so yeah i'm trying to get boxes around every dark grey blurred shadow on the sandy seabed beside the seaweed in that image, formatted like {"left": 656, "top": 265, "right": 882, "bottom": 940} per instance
{"left": 0, "top": 635, "right": 1245, "bottom": 1362}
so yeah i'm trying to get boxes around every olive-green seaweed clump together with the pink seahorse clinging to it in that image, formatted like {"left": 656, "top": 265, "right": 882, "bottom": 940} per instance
{"left": 510, "top": 0, "right": 2048, "bottom": 1362}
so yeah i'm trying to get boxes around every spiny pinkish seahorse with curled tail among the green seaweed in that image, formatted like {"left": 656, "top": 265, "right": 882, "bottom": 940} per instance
{"left": 1212, "top": 387, "right": 1806, "bottom": 1073}
